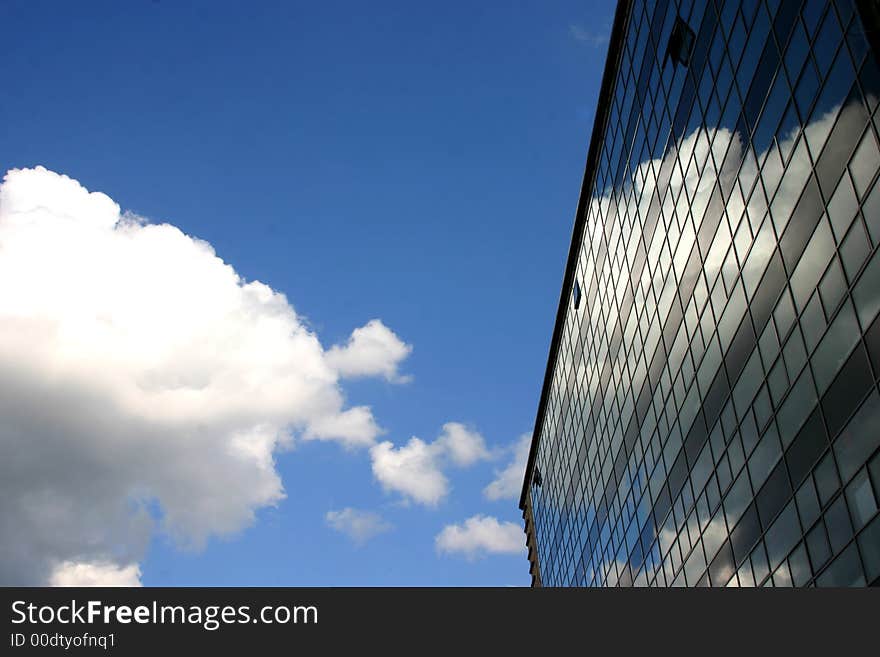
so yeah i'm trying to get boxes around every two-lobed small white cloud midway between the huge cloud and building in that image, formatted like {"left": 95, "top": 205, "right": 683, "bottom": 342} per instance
{"left": 370, "top": 422, "right": 490, "bottom": 506}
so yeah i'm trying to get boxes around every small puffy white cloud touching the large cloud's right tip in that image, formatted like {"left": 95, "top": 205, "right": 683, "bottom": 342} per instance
{"left": 327, "top": 319, "right": 412, "bottom": 383}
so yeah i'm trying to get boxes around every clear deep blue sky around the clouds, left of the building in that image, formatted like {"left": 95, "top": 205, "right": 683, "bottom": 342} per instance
{"left": 0, "top": 0, "right": 613, "bottom": 586}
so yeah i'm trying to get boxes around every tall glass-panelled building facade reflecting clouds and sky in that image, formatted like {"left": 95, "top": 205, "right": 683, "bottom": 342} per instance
{"left": 520, "top": 0, "right": 880, "bottom": 586}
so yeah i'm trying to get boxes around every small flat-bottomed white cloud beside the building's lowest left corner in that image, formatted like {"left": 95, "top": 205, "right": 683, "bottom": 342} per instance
{"left": 434, "top": 515, "right": 526, "bottom": 559}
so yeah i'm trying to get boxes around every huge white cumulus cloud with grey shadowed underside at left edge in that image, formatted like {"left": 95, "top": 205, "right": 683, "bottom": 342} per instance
{"left": 0, "top": 167, "right": 408, "bottom": 584}
